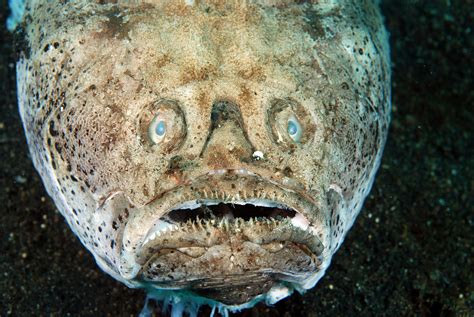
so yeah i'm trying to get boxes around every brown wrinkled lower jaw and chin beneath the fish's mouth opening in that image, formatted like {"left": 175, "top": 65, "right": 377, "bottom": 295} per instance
{"left": 140, "top": 241, "right": 318, "bottom": 305}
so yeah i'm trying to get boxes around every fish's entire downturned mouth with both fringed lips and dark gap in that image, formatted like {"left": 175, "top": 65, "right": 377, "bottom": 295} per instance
{"left": 128, "top": 170, "right": 325, "bottom": 305}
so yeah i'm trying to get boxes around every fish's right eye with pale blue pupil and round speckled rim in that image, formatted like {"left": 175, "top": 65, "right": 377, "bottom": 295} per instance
{"left": 267, "top": 99, "right": 315, "bottom": 148}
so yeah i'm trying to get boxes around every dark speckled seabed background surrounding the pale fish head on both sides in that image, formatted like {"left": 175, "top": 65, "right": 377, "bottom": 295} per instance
{"left": 0, "top": 0, "right": 474, "bottom": 316}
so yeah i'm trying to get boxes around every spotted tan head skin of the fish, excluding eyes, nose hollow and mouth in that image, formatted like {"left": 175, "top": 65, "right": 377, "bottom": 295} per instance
{"left": 18, "top": 1, "right": 390, "bottom": 308}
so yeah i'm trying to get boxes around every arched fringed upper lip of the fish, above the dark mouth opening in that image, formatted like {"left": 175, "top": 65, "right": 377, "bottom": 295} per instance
{"left": 122, "top": 169, "right": 327, "bottom": 279}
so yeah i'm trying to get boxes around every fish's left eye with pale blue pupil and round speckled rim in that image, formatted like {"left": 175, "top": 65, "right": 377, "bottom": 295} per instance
{"left": 139, "top": 100, "right": 186, "bottom": 151}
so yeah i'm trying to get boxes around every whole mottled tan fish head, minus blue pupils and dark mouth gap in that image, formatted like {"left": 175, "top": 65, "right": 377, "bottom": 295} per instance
{"left": 17, "top": 0, "right": 390, "bottom": 307}
